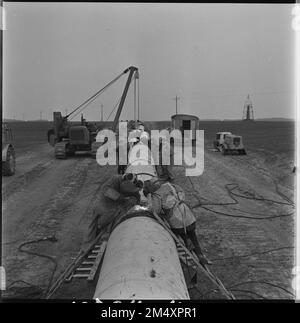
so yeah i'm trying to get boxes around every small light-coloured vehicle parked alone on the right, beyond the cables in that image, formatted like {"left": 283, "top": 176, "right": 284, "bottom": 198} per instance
{"left": 214, "top": 131, "right": 247, "bottom": 155}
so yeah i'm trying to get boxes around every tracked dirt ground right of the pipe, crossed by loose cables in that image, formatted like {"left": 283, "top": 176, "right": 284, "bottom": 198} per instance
{"left": 175, "top": 149, "right": 294, "bottom": 299}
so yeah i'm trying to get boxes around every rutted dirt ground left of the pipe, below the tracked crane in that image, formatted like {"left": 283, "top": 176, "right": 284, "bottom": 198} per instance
{"left": 2, "top": 145, "right": 112, "bottom": 297}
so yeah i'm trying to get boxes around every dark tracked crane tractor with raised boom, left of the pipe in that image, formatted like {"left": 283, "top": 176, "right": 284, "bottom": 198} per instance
{"left": 47, "top": 66, "right": 138, "bottom": 159}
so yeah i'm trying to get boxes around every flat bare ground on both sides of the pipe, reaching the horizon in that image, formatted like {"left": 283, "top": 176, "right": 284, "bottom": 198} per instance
{"left": 2, "top": 121, "right": 295, "bottom": 299}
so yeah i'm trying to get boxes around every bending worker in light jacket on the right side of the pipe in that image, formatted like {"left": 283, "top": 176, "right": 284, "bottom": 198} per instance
{"left": 144, "top": 183, "right": 211, "bottom": 265}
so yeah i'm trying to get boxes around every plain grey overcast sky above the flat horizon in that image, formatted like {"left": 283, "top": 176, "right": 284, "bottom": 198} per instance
{"left": 3, "top": 3, "right": 295, "bottom": 120}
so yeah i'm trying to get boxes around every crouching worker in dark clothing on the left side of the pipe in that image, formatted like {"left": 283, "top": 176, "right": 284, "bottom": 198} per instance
{"left": 85, "top": 173, "right": 140, "bottom": 243}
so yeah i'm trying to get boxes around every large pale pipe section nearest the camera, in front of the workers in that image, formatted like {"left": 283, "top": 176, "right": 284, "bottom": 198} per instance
{"left": 94, "top": 215, "right": 189, "bottom": 300}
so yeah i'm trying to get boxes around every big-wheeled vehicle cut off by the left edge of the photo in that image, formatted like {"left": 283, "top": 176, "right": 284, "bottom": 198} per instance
{"left": 2, "top": 123, "right": 16, "bottom": 176}
